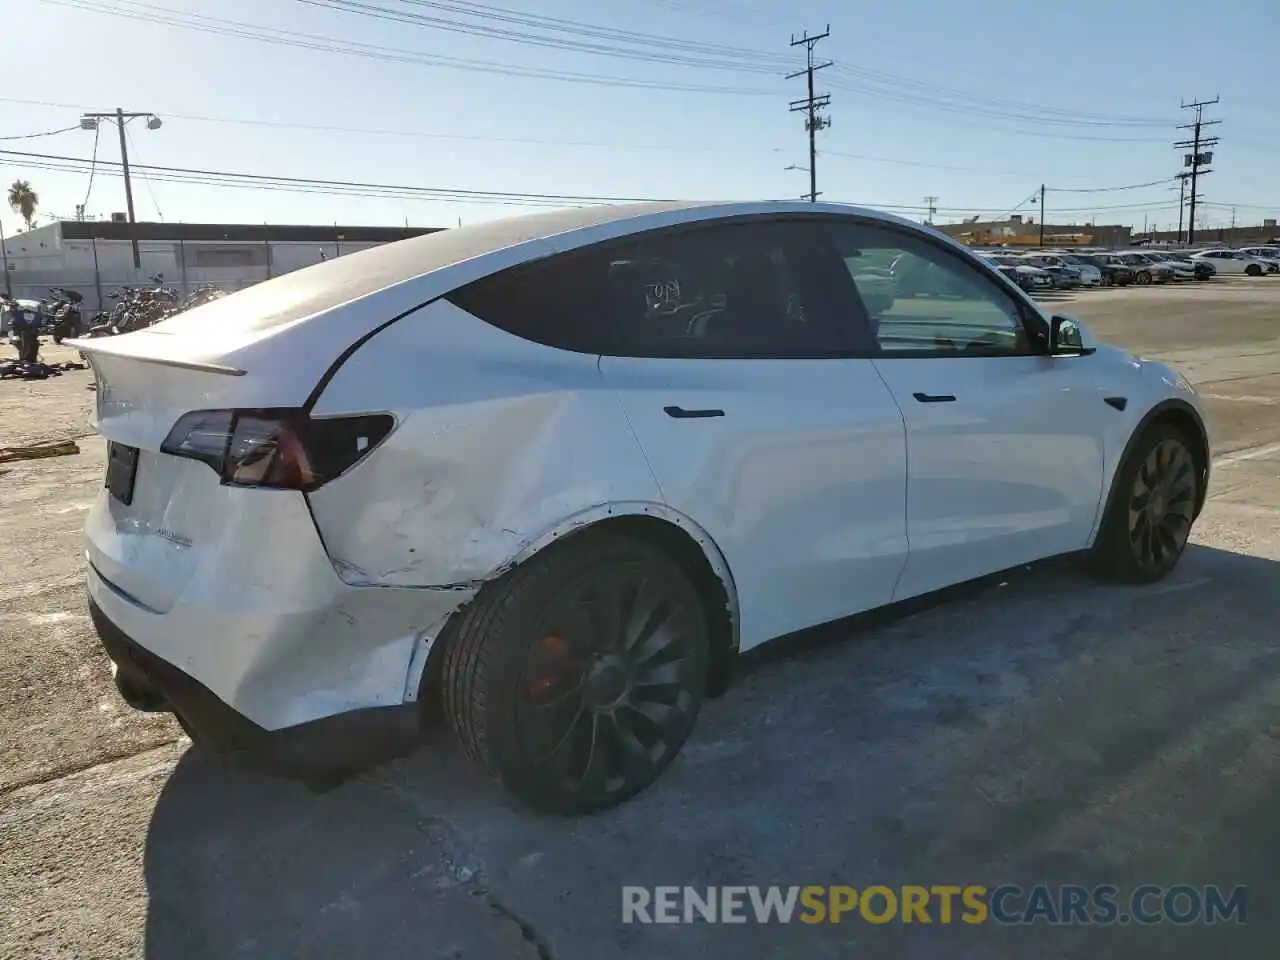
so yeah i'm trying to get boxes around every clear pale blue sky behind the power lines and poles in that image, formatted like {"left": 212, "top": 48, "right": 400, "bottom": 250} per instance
{"left": 0, "top": 0, "right": 1280, "bottom": 230}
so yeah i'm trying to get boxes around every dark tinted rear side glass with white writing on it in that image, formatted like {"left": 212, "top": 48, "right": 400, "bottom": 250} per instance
{"left": 449, "top": 221, "right": 846, "bottom": 357}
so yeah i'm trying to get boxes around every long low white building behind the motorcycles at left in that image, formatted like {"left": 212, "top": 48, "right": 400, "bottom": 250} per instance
{"left": 4, "top": 220, "right": 439, "bottom": 310}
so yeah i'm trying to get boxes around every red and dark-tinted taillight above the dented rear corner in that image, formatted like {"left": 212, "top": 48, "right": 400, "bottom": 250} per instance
{"left": 160, "top": 410, "right": 396, "bottom": 490}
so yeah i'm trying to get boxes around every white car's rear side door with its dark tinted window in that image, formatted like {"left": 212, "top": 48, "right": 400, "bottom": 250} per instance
{"left": 591, "top": 219, "right": 906, "bottom": 649}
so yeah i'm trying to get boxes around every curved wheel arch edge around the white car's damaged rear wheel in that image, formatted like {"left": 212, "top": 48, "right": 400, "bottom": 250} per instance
{"left": 417, "top": 500, "right": 741, "bottom": 710}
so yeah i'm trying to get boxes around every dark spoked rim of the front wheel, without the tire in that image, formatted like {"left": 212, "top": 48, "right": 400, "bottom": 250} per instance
{"left": 1129, "top": 438, "right": 1196, "bottom": 571}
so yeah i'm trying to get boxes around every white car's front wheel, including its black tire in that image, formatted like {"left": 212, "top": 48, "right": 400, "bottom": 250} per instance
{"left": 1089, "top": 424, "right": 1201, "bottom": 584}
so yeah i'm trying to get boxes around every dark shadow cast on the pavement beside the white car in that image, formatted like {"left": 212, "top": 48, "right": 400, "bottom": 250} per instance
{"left": 145, "top": 548, "right": 1280, "bottom": 960}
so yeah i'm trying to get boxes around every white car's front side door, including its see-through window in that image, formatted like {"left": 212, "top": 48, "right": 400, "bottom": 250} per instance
{"left": 832, "top": 223, "right": 1115, "bottom": 600}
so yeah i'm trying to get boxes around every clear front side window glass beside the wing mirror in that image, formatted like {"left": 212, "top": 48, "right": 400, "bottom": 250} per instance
{"left": 832, "top": 224, "right": 1033, "bottom": 356}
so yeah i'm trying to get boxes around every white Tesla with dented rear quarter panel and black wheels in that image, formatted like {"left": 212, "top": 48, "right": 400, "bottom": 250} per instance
{"left": 76, "top": 204, "right": 1208, "bottom": 810}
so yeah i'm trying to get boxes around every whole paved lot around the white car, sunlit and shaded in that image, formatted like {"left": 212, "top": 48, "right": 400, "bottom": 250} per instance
{"left": 0, "top": 278, "right": 1280, "bottom": 960}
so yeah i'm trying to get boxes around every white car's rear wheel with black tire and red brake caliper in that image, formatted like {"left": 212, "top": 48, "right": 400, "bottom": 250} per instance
{"left": 440, "top": 531, "right": 710, "bottom": 813}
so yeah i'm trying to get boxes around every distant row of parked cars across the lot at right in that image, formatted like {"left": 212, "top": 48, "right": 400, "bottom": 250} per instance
{"left": 975, "top": 246, "right": 1280, "bottom": 292}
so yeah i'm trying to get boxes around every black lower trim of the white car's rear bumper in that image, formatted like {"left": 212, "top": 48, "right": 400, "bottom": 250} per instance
{"left": 88, "top": 596, "right": 421, "bottom": 780}
